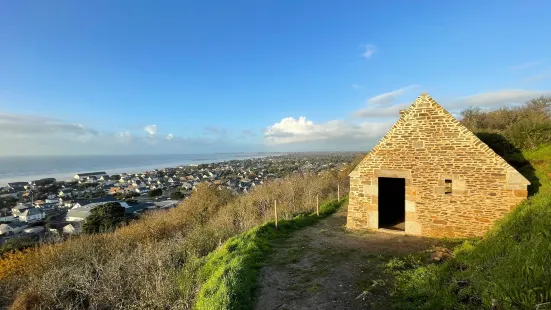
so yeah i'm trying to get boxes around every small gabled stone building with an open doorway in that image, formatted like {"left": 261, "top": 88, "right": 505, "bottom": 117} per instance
{"left": 347, "top": 93, "right": 530, "bottom": 237}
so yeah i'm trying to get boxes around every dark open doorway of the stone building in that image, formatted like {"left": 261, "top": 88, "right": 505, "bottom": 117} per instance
{"left": 379, "top": 178, "right": 406, "bottom": 230}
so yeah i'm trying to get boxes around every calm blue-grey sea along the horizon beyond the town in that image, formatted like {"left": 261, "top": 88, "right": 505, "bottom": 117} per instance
{"left": 0, "top": 152, "right": 282, "bottom": 186}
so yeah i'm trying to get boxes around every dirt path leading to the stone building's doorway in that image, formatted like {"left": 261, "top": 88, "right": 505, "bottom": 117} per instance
{"left": 255, "top": 208, "right": 446, "bottom": 310}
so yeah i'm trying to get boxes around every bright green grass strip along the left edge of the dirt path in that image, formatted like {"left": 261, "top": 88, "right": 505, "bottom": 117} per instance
{"left": 189, "top": 200, "right": 346, "bottom": 310}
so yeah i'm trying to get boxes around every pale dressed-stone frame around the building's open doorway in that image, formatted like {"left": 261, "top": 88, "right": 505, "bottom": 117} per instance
{"left": 364, "top": 169, "right": 422, "bottom": 235}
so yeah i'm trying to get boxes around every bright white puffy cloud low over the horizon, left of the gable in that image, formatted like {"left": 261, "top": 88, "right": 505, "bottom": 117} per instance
{"left": 264, "top": 116, "right": 392, "bottom": 145}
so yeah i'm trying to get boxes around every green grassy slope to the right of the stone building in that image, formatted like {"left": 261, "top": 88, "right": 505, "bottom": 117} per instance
{"left": 388, "top": 146, "right": 551, "bottom": 309}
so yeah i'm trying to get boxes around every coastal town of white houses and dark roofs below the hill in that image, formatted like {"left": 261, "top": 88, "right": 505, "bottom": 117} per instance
{"left": 0, "top": 152, "right": 359, "bottom": 245}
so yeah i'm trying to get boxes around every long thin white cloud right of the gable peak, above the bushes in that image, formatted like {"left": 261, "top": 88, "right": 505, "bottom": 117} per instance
{"left": 447, "top": 89, "right": 551, "bottom": 109}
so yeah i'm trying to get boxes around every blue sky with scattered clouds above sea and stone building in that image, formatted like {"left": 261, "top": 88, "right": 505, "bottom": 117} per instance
{"left": 0, "top": 0, "right": 551, "bottom": 155}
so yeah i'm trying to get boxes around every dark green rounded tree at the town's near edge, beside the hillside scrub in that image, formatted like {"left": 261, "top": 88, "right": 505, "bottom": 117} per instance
{"left": 82, "top": 202, "right": 125, "bottom": 234}
